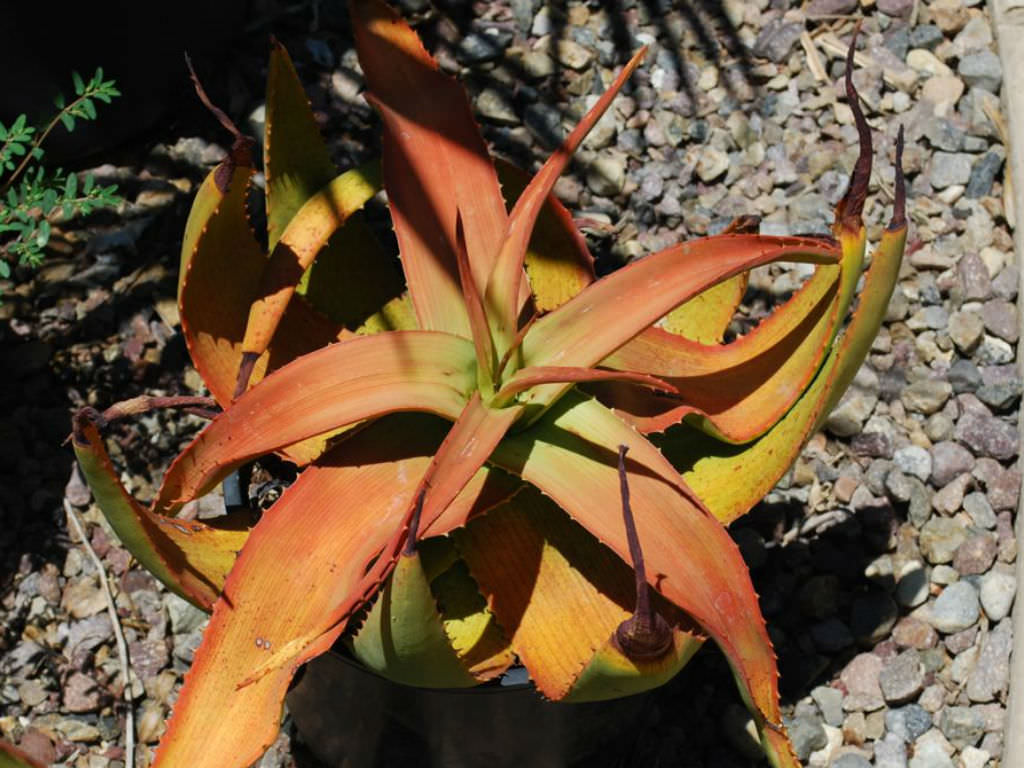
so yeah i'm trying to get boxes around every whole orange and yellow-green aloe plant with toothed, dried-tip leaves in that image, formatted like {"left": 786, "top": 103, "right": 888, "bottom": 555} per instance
{"left": 74, "top": 6, "right": 906, "bottom": 768}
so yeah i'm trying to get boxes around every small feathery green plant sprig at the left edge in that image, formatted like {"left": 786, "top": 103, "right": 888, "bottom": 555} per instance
{"left": 0, "top": 68, "right": 121, "bottom": 280}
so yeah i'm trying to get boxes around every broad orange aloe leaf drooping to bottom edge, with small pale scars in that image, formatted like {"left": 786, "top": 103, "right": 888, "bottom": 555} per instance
{"left": 156, "top": 415, "right": 512, "bottom": 768}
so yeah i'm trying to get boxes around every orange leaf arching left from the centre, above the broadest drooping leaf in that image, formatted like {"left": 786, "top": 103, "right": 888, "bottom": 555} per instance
{"left": 154, "top": 331, "right": 475, "bottom": 513}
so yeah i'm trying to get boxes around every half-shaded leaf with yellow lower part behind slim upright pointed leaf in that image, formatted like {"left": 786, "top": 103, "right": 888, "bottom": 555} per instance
{"left": 496, "top": 160, "right": 594, "bottom": 312}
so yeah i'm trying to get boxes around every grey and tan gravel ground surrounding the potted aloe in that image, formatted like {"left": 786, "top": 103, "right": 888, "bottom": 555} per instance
{"left": 0, "top": 0, "right": 1022, "bottom": 768}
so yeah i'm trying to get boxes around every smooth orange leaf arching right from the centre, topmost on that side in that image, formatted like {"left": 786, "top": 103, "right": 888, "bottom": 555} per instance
{"left": 522, "top": 234, "right": 837, "bottom": 417}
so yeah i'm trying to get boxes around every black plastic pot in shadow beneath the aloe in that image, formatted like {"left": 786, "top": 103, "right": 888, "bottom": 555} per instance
{"left": 288, "top": 651, "right": 651, "bottom": 768}
